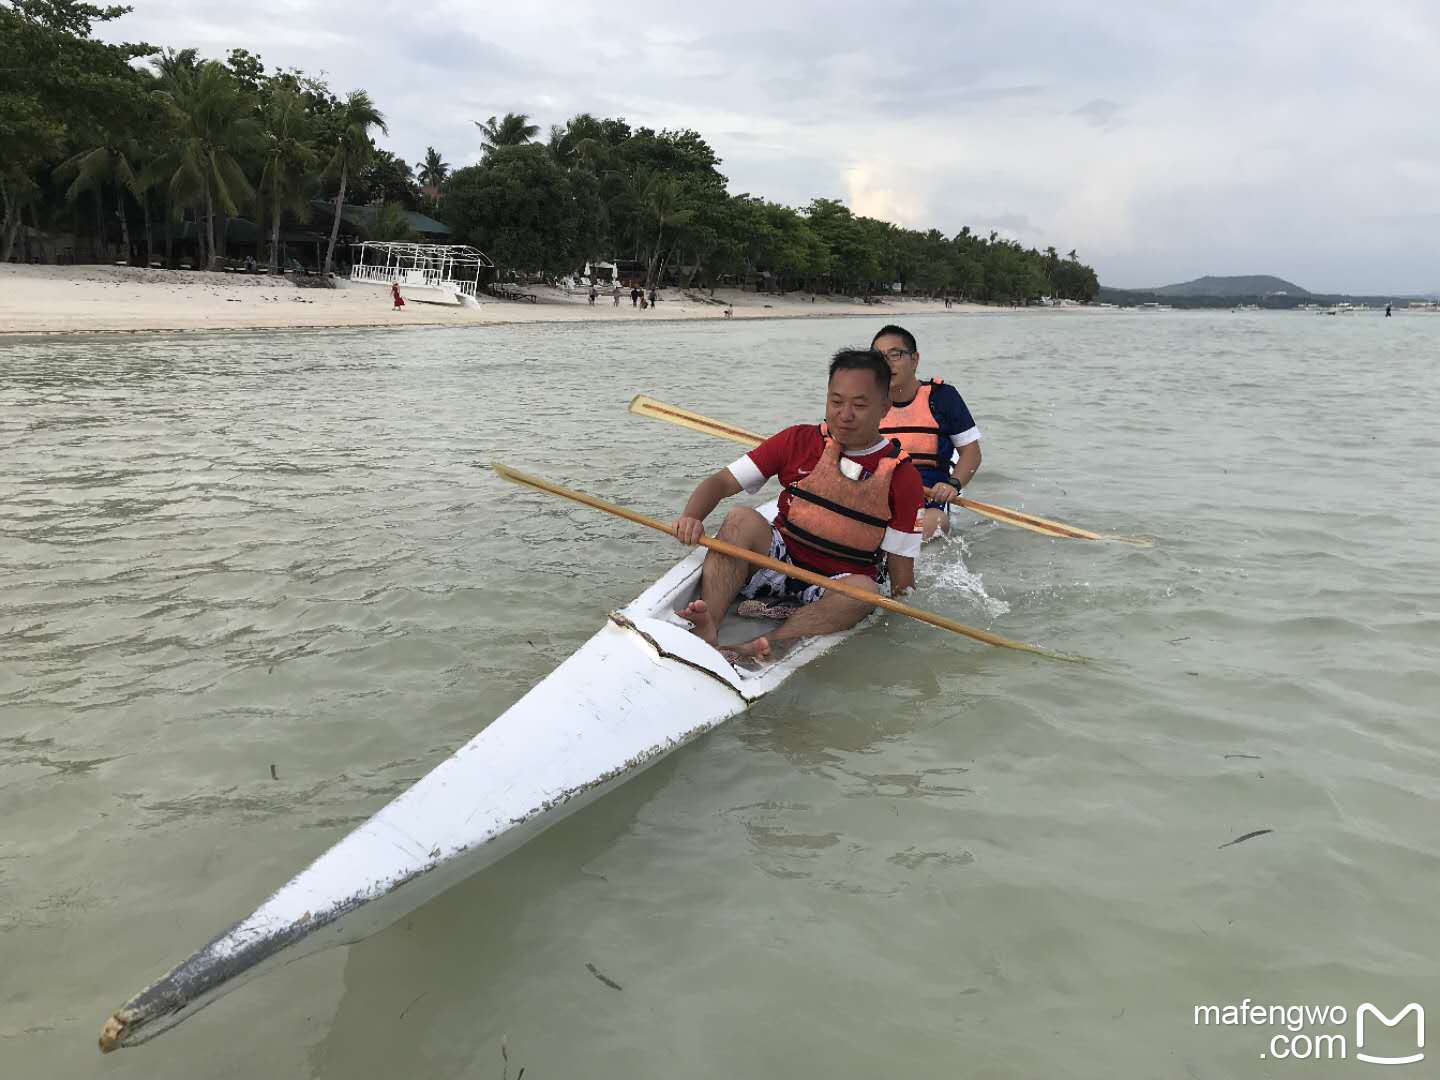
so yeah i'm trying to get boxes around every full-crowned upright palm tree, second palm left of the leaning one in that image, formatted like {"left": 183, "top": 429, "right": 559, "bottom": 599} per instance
{"left": 160, "top": 60, "right": 259, "bottom": 269}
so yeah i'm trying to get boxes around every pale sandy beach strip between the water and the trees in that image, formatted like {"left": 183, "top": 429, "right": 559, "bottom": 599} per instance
{"left": 0, "top": 264, "right": 1079, "bottom": 334}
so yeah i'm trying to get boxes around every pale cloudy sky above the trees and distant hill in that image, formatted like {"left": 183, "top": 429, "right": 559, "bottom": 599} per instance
{"left": 105, "top": 0, "right": 1440, "bottom": 294}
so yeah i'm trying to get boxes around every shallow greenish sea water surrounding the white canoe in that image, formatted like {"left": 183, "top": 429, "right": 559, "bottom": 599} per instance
{"left": 0, "top": 312, "right": 1440, "bottom": 1080}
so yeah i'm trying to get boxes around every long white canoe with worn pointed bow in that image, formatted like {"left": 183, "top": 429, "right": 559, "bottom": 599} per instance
{"left": 99, "top": 503, "right": 864, "bottom": 1050}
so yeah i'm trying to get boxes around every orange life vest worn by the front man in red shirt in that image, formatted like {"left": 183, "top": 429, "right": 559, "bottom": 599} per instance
{"left": 775, "top": 423, "right": 907, "bottom": 566}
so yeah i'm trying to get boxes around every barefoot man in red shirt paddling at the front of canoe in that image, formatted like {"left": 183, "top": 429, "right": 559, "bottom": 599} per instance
{"left": 675, "top": 348, "right": 924, "bottom": 660}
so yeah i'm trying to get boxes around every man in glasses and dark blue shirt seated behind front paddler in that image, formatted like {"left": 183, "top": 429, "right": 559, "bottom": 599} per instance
{"left": 870, "top": 325, "right": 981, "bottom": 540}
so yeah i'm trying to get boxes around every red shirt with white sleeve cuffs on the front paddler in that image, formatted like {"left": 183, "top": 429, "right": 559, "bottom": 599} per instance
{"left": 730, "top": 423, "right": 924, "bottom": 577}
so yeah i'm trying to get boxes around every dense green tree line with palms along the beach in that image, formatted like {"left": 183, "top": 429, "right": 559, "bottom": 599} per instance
{"left": 0, "top": 0, "right": 1099, "bottom": 304}
